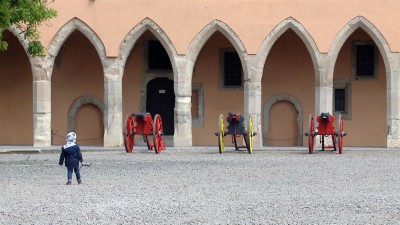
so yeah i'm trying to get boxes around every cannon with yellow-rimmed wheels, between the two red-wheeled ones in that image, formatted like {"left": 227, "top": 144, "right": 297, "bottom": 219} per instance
{"left": 215, "top": 112, "right": 256, "bottom": 154}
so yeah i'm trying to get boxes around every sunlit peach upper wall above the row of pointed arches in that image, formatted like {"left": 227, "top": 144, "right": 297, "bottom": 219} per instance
{"left": 41, "top": 0, "right": 400, "bottom": 57}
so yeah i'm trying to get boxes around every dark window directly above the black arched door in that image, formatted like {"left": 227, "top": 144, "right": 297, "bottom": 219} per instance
{"left": 148, "top": 40, "right": 172, "bottom": 70}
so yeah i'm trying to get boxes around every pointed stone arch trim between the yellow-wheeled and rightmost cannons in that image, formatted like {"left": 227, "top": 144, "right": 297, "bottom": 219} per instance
{"left": 257, "top": 17, "right": 320, "bottom": 81}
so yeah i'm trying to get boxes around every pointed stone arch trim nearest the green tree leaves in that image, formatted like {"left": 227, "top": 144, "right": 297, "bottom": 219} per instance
{"left": 48, "top": 17, "right": 107, "bottom": 67}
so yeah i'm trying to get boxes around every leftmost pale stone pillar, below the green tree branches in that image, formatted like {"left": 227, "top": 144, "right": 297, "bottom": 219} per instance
{"left": 31, "top": 57, "right": 52, "bottom": 147}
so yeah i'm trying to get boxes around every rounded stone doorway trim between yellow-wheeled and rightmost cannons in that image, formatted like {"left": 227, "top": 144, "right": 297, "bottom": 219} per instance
{"left": 262, "top": 93, "right": 303, "bottom": 146}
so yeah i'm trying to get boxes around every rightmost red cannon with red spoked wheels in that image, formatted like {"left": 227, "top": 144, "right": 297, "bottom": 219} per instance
{"left": 304, "top": 113, "right": 347, "bottom": 154}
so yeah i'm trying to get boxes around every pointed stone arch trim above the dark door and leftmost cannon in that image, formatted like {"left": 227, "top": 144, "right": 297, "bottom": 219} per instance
{"left": 118, "top": 18, "right": 177, "bottom": 78}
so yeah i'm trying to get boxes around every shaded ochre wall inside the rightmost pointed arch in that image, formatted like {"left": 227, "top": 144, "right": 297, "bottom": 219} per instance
{"left": 333, "top": 29, "right": 388, "bottom": 146}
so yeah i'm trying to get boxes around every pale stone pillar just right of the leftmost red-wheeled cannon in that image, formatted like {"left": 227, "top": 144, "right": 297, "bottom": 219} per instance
{"left": 174, "top": 56, "right": 194, "bottom": 147}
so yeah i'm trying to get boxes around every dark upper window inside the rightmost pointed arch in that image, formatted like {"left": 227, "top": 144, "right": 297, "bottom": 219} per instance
{"left": 354, "top": 43, "right": 376, "bottom": 78}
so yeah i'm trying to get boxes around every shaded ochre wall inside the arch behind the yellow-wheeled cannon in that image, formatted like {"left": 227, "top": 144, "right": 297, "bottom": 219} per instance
{"left": 192, "top": 32, "right": 244, "bottom": 146}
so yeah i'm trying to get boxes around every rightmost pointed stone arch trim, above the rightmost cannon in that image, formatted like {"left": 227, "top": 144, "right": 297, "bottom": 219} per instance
{"left": 329, "top": 16, "right": 391, "bottom": 73}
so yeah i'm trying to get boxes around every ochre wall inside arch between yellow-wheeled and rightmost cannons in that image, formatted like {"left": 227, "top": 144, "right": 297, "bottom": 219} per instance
{"left": 262, "top": 30, "right": 315, "bottom": 146}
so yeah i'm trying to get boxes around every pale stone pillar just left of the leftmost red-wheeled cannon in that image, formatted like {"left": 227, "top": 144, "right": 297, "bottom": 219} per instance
{"left": 104, "top": 59, "right": 124, "bottom": 147}
